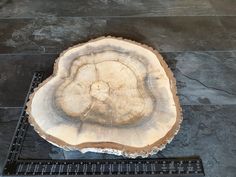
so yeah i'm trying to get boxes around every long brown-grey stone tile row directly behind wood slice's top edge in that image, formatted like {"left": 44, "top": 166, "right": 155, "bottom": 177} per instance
{"left": 0, "top": 16, "right": 236, "bottom": 54}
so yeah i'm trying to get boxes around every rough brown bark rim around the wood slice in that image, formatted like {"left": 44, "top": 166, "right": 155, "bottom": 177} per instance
{"left": 26, "top": 36, "right": 183, "bottom": 158}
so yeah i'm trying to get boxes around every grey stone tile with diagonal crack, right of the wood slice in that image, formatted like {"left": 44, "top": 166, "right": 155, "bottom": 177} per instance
{"left": 167, "top": 52, "right": 236, "bottom": 105}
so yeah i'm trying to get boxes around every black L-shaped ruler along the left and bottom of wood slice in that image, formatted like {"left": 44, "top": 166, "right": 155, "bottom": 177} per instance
{"left": 3, "top": 72, "right": 204, "bottom": 177}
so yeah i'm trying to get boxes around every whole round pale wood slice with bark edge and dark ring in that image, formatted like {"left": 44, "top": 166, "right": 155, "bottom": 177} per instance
{"left": 27, "top": 37, "right": 182, "bottom": 157}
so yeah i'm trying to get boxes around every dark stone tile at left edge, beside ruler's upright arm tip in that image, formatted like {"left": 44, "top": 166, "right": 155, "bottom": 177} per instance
{"left": 0, "top": 55, "right": 57, "bottom": 107}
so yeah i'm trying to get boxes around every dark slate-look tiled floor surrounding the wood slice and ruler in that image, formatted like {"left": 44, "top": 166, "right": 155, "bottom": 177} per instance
{"left": 0, "top": 0, "right": 236, "bottom": 177}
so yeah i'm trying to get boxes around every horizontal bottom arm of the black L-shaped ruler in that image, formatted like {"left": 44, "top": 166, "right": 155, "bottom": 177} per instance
{"left": 5, "top": 158, "right": 204, "bottom": 176}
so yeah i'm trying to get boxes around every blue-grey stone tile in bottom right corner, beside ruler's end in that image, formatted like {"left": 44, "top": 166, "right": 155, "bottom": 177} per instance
{"left": 162, "top": 105, "right": 236, "bottom": 177}
